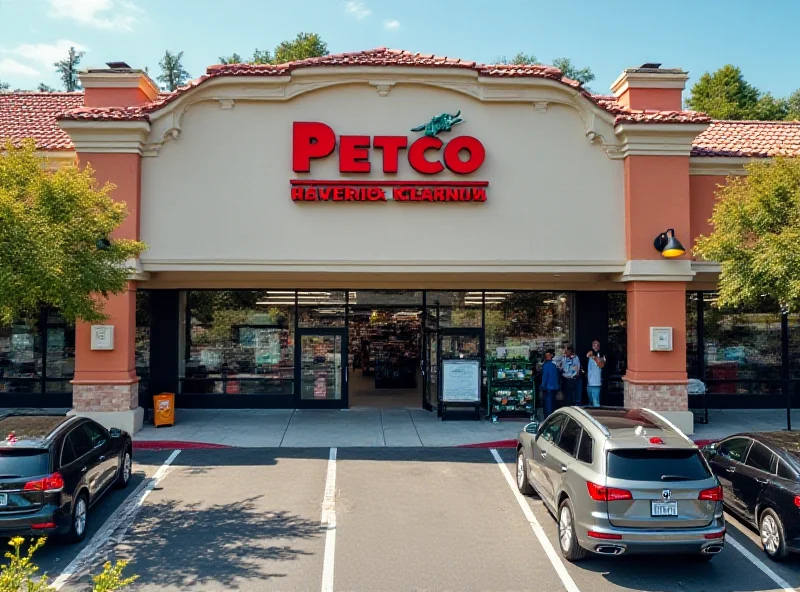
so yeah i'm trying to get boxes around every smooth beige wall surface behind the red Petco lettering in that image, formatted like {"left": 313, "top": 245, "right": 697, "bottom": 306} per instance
{"left": 141, "top": 84, "right": 625, "bottom": 272}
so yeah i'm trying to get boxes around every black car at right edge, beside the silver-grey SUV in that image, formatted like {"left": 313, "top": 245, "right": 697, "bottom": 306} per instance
{"left": 703, "top": 432, "right": 800, "bottom": 561}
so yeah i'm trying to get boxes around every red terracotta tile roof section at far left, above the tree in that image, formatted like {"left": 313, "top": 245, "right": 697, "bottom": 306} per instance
{"left": 0, "top": 92, "right": 83, "bottom": 150}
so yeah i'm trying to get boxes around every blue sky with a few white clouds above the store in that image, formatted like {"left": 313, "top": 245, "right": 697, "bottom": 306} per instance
{"left": 0, "top": 0, "right": 800, "bottom": 96}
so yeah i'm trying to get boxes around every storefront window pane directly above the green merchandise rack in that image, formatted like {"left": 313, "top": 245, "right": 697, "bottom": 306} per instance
{"left": 486, "top": 292, "right": 572, "bottom": 360}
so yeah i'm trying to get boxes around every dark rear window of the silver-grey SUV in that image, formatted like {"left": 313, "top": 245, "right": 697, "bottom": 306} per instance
{"left": 608, "top": 448, "right": 711, "bottom": 481}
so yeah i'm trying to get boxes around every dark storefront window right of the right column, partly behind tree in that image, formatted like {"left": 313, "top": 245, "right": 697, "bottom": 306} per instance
{"left": 702, "top": 293, "right": 781, "bottom": 394}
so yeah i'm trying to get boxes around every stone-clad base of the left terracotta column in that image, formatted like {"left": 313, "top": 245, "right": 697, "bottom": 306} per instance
{"left": 69, "top": 381, "right": 144, "bottom": 435}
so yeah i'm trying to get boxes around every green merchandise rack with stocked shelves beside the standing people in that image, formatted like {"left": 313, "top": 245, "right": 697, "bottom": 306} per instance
{"left": 486, "top": 359, "right": 536, "bottom": 421}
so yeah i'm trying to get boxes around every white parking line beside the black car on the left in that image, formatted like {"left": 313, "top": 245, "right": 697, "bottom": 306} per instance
{"left": 51, "top": 450, "right": 180, "bottom": 590}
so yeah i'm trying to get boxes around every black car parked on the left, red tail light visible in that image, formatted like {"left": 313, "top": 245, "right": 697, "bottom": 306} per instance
{"left": 0, "top": 413, "right": 132, "bottom": 542}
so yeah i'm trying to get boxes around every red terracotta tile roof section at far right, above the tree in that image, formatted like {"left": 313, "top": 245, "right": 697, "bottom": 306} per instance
{"left": 692, "top": 121, "right": 800, "bottom": 158}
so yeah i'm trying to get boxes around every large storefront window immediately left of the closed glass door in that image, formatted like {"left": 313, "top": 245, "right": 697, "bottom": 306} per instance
{"left": 181, "top": 290, "right": 295, "bottom": 395}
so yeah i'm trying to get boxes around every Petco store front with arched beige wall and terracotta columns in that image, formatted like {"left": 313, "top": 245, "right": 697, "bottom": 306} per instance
{"left": 1, "top": 50, "right": 800, "bottom": 427}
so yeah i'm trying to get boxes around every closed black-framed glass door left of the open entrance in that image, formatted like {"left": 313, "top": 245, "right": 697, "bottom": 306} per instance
{"left": 298, "top": 329, "right": 348, "bottom": 409}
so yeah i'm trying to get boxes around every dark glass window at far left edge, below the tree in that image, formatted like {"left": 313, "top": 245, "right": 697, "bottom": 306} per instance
{"left": 0, "top": 319, "right": 42, "bottom": 393}
